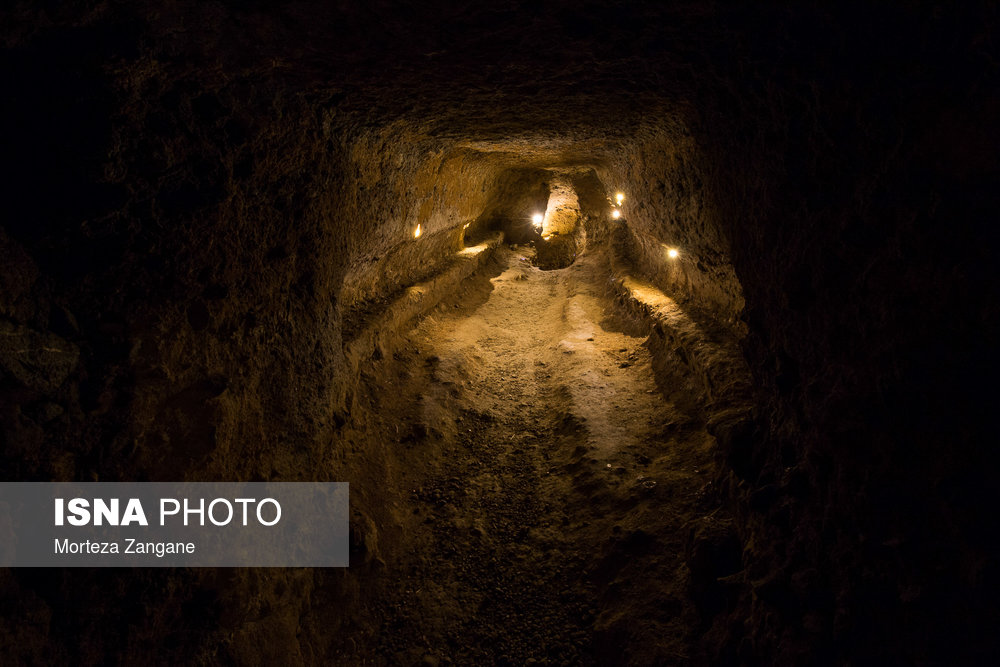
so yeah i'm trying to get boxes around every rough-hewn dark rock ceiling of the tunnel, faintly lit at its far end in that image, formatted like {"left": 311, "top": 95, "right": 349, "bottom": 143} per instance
{"left": 2, "top": 1, "right": 988, "bottom": 164}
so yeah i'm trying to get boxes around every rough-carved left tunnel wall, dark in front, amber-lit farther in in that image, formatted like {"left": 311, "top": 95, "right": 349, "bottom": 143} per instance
{"left": 0, "top": 8, "right": 532, "bottom": 664}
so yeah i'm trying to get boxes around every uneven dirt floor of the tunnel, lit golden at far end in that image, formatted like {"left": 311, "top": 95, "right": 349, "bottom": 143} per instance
{"left": 343, "top": 246, "right": 719, "bottom": 665}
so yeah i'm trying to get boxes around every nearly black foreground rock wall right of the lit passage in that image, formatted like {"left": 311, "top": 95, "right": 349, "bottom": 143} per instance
{"left": 682, "top": 6, "right": 1000, "bottom": 664}
